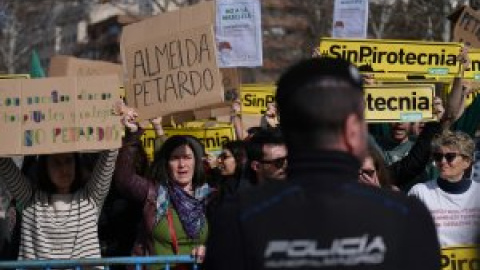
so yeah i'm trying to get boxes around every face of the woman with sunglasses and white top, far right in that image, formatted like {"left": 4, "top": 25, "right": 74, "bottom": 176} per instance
{"left": 433, "top": 146, "right": 470, "bottom": 182}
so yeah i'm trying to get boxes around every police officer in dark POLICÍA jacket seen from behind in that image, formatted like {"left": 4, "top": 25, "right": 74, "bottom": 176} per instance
{"left": 205, "top": 57, "right": 440, "bottom": 270}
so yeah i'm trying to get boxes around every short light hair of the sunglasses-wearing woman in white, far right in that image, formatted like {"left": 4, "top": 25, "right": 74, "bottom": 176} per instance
{"left": 432, "top": 130, "right": 475, "bottom": 160}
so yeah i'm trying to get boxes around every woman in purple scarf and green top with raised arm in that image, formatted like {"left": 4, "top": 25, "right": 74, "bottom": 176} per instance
{"left": 114, "top": 108, "right": 210, "bottom": 269}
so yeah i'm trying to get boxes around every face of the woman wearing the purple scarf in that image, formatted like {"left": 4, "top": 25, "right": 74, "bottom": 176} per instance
{"left": 168, "top": 145, "right": 195, "bottom": 187}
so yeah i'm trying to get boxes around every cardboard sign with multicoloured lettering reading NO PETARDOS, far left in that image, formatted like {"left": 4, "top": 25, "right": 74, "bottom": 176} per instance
{"left": 0, "top": 75, "right": 123, "bottom": 156}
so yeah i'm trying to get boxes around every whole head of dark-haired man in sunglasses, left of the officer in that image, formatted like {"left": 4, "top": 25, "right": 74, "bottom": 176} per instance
{"left": 247, "top": 129, "right": 287, "bottom": 185}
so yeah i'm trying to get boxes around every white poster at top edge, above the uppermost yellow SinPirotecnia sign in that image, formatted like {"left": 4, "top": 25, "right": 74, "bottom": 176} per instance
{"left": 332, "top": 0, "right": 368, "bottom": 38}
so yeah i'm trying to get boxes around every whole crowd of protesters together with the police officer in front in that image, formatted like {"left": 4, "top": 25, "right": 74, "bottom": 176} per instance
{"left": 0, "top": 47, "right": 480, "bottom": 270}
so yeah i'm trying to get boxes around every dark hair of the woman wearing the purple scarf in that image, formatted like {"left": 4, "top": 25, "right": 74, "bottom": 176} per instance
{"left": 148, "top": 135, "right": 205, "bottom": 188}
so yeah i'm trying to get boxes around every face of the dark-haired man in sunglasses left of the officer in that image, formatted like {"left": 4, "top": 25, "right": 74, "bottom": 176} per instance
{"left": 256, "top": 144, "right": 287, "bottom": 181}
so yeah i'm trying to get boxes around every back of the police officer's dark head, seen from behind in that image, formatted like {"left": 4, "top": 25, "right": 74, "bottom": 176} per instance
{"left": 276, "top": 57, "right": 364, "bottom": 148}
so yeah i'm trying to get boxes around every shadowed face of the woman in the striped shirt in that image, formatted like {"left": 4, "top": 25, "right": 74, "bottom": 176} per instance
{"left": 47, "top": 153, "right": 75, "bottom": 194}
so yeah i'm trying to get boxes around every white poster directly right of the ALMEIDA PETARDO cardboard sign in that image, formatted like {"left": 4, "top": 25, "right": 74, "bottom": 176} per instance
{"left": 216, "top": 0, "right": 263, "bottom": 67}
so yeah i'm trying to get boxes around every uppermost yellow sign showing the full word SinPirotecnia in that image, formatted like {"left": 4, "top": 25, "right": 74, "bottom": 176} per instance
{"left": 319, "top": 38, "right": 461, "bottom": 76}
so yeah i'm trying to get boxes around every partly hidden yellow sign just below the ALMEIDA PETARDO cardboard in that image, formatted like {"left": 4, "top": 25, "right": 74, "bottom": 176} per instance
{"left": 141, "top": 125, "right": 235, "bottom": 161}
